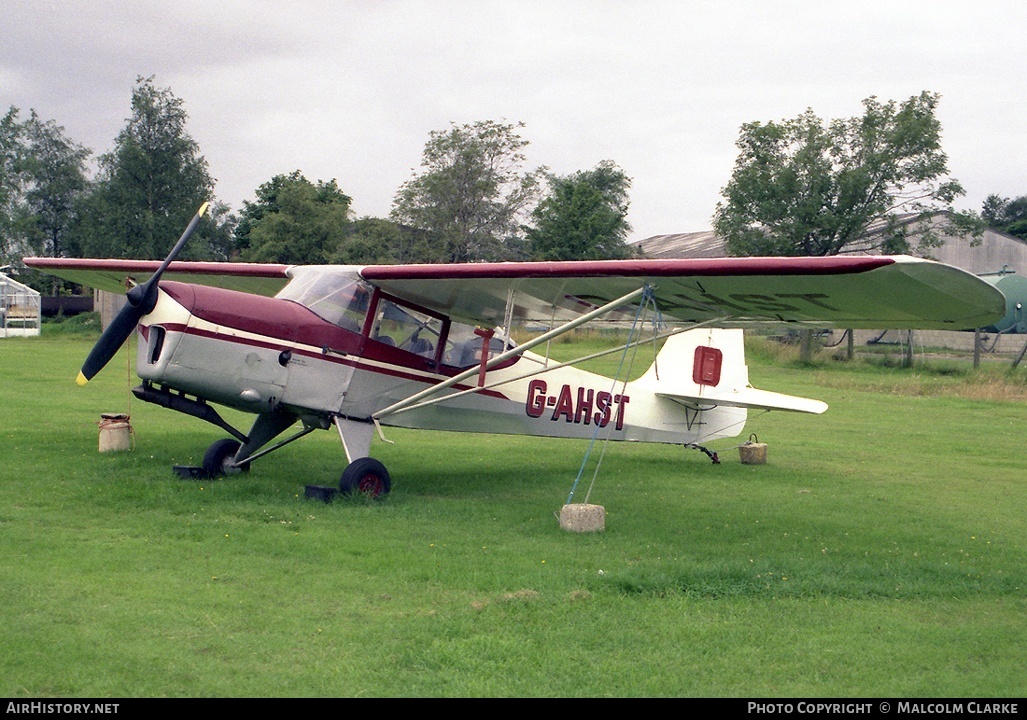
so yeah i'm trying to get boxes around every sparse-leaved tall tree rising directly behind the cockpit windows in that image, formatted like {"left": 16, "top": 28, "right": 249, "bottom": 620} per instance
{"left": 391, "top": 120, "right": 542, "bottom": 262}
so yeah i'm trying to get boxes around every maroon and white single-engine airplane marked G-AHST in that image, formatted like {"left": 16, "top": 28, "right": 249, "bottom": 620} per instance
{"left": 25, "top": 202, "right": 1005, "bottom": 495}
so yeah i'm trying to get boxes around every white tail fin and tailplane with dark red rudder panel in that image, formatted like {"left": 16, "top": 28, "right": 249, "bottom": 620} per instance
{"left": 642, "top": 328, "right": 828, "bottom": 415}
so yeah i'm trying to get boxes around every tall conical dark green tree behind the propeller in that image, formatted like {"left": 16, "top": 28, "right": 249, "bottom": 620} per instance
{"left": 75, "top": 77, "right": 227, "bottom": 259}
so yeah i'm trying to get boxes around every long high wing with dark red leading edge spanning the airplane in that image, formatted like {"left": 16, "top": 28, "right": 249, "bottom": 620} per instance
{"left": 25, "top": 256, "right": 1005, "bottom": 330}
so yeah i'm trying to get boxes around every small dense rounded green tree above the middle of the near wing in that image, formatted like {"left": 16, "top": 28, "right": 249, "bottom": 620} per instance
{"left": 528, "top": 160, "right": 633, "bottom": 260}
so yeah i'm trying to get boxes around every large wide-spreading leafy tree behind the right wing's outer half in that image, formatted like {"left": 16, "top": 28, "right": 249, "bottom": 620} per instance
{"left": 714, "top": 91, "right": 980, "bottom": 256}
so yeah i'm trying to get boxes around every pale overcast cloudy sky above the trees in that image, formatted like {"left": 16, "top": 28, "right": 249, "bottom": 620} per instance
{"left": 0, "top": 0, "right": 1027, "bottom": 240}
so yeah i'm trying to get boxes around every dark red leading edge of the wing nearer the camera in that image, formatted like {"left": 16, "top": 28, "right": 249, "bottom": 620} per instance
{"left": 360, "top": 256, "right": 895, "bottom": 281}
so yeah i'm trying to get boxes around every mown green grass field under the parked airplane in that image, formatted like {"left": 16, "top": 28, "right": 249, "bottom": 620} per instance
{"left": 0, "top": 329, "right": 1027, "bottom": 697}
